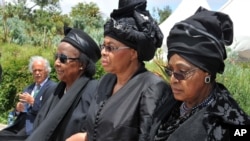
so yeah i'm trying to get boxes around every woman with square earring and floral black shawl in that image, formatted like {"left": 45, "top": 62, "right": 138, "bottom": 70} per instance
{"left": 151, "top": 7, "right": 250, "bottom": 141}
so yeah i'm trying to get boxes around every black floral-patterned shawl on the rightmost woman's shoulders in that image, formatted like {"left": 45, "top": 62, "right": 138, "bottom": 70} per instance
{"left": 150, "top": 83, "right": 250, "bottom": 141}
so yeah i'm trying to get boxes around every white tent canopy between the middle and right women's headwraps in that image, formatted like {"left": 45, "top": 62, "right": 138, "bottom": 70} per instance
{"left": 159, "top": 0, "right": 211, "bottom": 53}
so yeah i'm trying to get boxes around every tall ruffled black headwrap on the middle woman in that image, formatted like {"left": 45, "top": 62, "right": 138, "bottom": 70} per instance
{"left": 104, "top": 0, "right": 163, "bottom": 61}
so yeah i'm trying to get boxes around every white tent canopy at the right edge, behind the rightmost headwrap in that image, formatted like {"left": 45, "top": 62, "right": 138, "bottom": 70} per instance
{"left": 219, "top": 0, "right": 250, "bottom": 59}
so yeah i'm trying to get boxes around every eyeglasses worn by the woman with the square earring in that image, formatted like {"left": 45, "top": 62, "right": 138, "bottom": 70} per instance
{"left": 165, "top": 67, "right": 198, "bottom": 80}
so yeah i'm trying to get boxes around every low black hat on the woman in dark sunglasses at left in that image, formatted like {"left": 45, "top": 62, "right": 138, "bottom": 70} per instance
{"left": 61, "top": 27, "right": 101, "bottom": 62}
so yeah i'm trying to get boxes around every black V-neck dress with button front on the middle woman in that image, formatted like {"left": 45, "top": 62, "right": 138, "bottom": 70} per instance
{"left": 85, "top": 68, "right": 170, "bottom": 141}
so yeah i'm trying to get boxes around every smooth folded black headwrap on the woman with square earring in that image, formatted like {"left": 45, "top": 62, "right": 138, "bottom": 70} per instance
{"left": 167, "top": 7, "right": 233, "bottom": 75}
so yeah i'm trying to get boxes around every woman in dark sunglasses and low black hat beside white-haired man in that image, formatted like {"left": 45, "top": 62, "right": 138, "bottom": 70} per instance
{"left": 27, "top": 27, "right": 101, "bottom": 141}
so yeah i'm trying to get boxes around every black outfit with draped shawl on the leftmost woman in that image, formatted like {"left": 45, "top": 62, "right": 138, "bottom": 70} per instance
{"left": 27, "top": 76, "right": 98, "bottom": 141}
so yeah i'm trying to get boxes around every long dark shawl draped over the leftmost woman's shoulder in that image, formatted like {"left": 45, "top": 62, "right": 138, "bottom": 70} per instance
{"left": 27, "top": 77, "right": 94, "bottom": 141}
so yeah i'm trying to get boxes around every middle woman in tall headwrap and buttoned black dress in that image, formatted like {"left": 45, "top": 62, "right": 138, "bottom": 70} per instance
{"left": 67, "top": 0, "right": 170, "bottom": 141}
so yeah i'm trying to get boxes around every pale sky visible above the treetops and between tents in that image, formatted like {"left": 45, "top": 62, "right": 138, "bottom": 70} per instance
{"left": 60, "top": 0, "right": 228, "bottom": 16}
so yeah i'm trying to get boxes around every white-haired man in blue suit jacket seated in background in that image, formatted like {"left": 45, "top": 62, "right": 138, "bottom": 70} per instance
{"left": 0, "top": 56, "right": 57, "bottom": 140}
